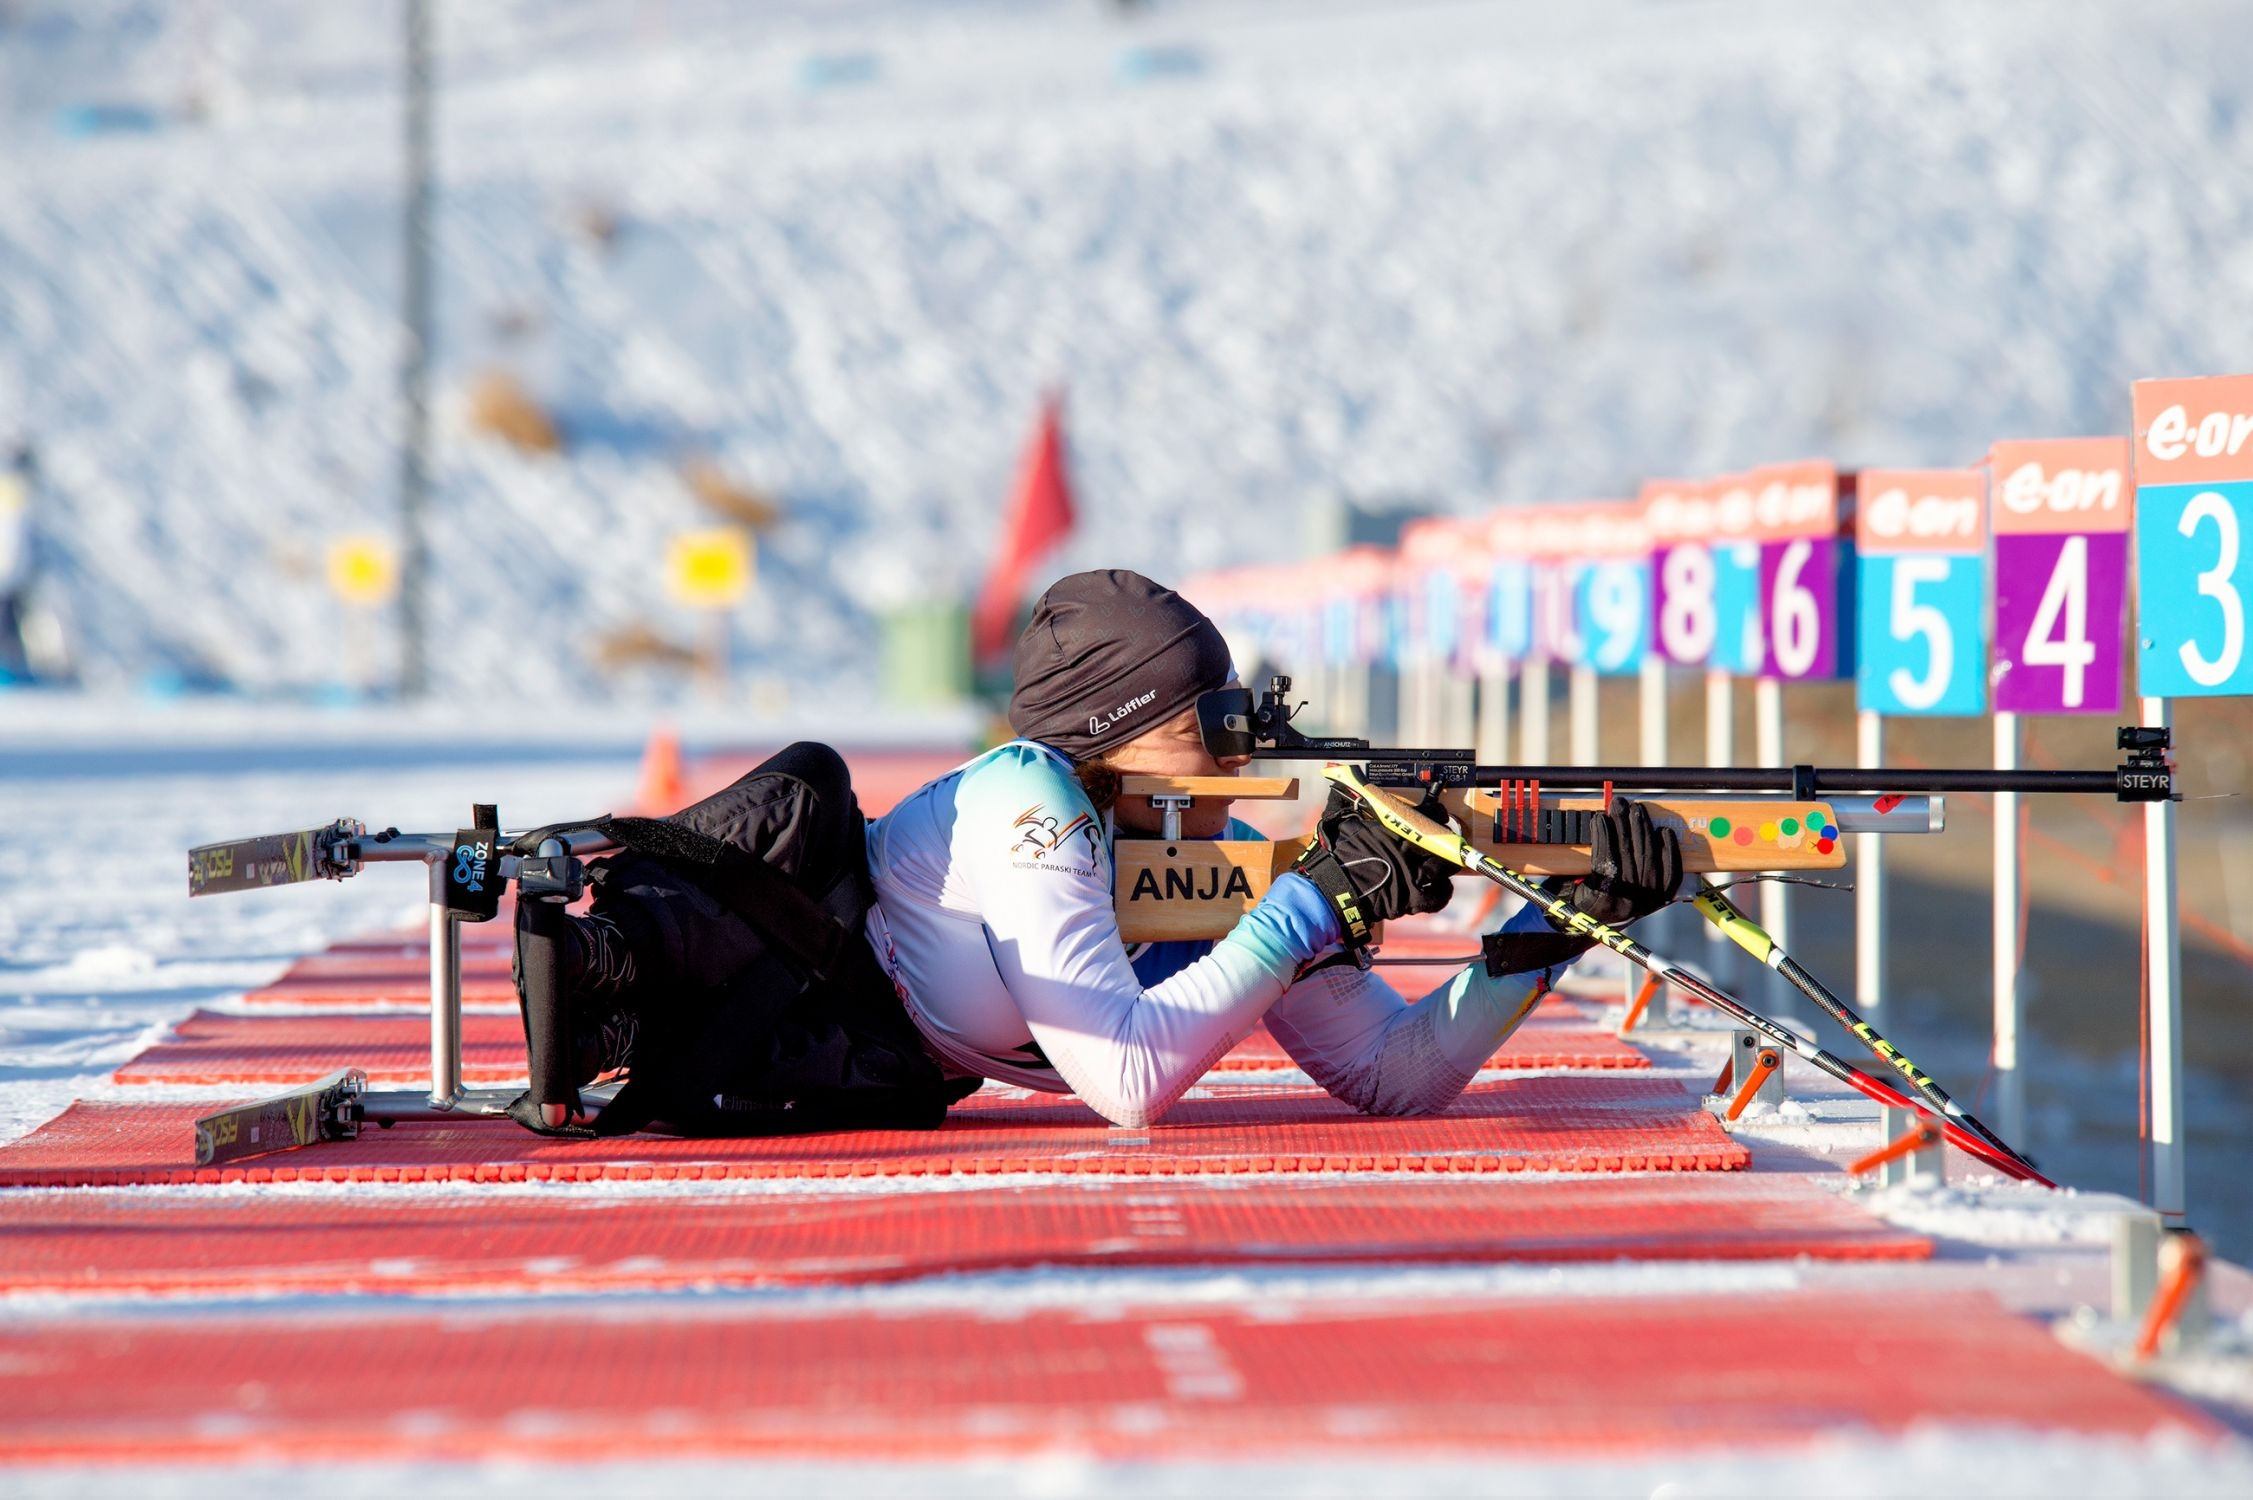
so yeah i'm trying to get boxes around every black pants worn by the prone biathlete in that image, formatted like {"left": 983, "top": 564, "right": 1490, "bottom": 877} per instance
{"left": 595, "top": 741, "right": 978, "bottom": 1135}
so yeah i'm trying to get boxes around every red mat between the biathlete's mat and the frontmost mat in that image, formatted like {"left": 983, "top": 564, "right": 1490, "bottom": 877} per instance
{"left": 0, "top": 1173, "right": 1933, "bottom": 1295}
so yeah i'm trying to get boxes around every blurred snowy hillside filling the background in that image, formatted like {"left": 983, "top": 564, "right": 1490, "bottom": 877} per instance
{"left": 0, "top": 0, "right": 2253, "bottom": 698}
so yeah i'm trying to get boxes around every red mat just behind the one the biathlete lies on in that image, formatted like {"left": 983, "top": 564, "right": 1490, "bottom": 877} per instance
{"left": 110, "top": 1007, "right": 1651, "bottom": 1088}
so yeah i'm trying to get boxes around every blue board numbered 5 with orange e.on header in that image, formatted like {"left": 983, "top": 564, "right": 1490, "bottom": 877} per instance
{"left": 1854, "top": 468, "right": 1987, "bottom": 716}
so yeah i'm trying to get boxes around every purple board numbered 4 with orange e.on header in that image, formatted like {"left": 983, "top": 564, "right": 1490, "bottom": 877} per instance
{"left": 1987, "top": 437, "right": 2134, "bottom": 714}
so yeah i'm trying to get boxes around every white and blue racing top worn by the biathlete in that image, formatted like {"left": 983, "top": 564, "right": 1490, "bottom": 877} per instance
{"left": 867, "top": 741, "right": 1546, "bottom": 1126}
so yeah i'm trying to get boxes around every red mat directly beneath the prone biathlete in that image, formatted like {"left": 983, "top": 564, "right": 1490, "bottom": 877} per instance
{"left": 0, "top": 1077, "right": 1751, "bottom": 1187}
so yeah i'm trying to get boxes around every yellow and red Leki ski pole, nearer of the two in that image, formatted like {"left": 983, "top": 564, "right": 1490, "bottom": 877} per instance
{"left": 1323, "top": 766, "right": 2057, "bottom": 1187}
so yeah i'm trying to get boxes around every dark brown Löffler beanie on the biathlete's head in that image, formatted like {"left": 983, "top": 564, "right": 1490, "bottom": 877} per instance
{"left": 1009, "top": 568, "right": 1230, "bottom": 761}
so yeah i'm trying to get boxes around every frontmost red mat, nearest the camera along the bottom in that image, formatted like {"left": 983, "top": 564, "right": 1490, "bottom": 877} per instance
{"left": 0, "top": 1291, "right": 2226, "bottom": 1464}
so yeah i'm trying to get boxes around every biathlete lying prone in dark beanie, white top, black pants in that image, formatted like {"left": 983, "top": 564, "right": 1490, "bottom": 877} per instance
{"left": 518, "top": 570, "right": 1681, "bottom": 1135}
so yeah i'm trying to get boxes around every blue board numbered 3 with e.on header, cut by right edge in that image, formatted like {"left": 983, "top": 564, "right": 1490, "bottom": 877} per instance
{"left": 2136, "top": 376, "right": 2253, "bottom": 698}
